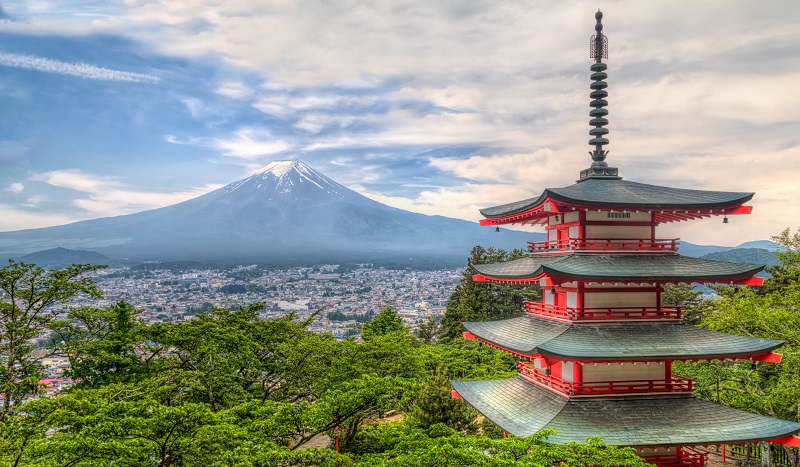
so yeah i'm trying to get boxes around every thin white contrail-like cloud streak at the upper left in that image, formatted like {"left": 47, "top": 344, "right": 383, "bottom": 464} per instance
{"left": 0, "top": 52, "right": 160, "bottom": 83}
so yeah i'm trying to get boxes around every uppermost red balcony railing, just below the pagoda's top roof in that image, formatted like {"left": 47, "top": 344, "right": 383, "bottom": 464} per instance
{"left": 528, "top": 238, "right": 678, "bottom": 253}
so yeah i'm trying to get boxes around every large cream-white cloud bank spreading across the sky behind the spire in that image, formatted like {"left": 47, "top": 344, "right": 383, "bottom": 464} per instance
{"left": 3, "top": 0, "right": 800, "bottom": 245}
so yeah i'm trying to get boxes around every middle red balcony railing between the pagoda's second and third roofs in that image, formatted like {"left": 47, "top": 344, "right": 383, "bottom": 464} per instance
{"left": 525, "top": 302, "right": 682, "bottom": 321}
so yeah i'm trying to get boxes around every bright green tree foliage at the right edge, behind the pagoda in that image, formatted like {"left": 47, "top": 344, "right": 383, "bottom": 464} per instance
{"left": 674, "top": 229, "right": 800, "bottom": 465}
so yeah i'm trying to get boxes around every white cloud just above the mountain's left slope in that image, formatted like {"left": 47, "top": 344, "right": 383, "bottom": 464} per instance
{"left": 33, "top": 169, "right": 221, "bottom": 216}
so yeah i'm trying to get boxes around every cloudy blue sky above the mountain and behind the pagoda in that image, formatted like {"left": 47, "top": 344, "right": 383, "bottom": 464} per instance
{"left": 0, "top": 0, "right": 800, "bottom": 246}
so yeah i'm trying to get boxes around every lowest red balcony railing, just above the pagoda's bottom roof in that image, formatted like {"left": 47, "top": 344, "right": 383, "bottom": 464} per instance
{"left": 517, "top": 362, "right": 694, "bottom": 397}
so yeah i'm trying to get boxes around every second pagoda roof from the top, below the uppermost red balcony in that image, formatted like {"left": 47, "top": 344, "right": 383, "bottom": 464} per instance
{"left": 474, "top": 253, "right": 764, "bottom": 282}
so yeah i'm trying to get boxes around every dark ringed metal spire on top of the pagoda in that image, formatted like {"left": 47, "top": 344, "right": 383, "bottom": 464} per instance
{"left": 578, "top": 9, "right": 622, "bottom": 182}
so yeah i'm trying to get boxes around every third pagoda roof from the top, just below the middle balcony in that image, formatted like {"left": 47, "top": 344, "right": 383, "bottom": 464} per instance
{"left": 462, "top": 316, "right": 783, "bottom": 361}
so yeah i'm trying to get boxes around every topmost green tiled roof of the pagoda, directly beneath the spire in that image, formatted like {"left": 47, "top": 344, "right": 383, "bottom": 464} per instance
{"left": 481, "top": 179, "right": 754, "bottom": 218}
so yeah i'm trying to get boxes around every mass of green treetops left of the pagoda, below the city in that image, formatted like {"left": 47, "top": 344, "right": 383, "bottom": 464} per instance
{"left": 0, "top": 262, "right": 641, "bottom": 467}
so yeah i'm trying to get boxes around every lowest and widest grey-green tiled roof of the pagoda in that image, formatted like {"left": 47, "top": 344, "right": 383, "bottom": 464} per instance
{"left": 451, "top": 377, "right": 800, "bottom": 447}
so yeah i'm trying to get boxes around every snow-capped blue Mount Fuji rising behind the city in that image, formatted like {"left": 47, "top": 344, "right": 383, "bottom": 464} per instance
{"left": 0, "top": 161, "right": 543, "bottom": 266}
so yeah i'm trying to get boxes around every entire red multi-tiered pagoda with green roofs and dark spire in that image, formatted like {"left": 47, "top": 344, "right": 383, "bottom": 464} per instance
{"left": 452, "top": 11, "right": 800, "bottom": 466}
